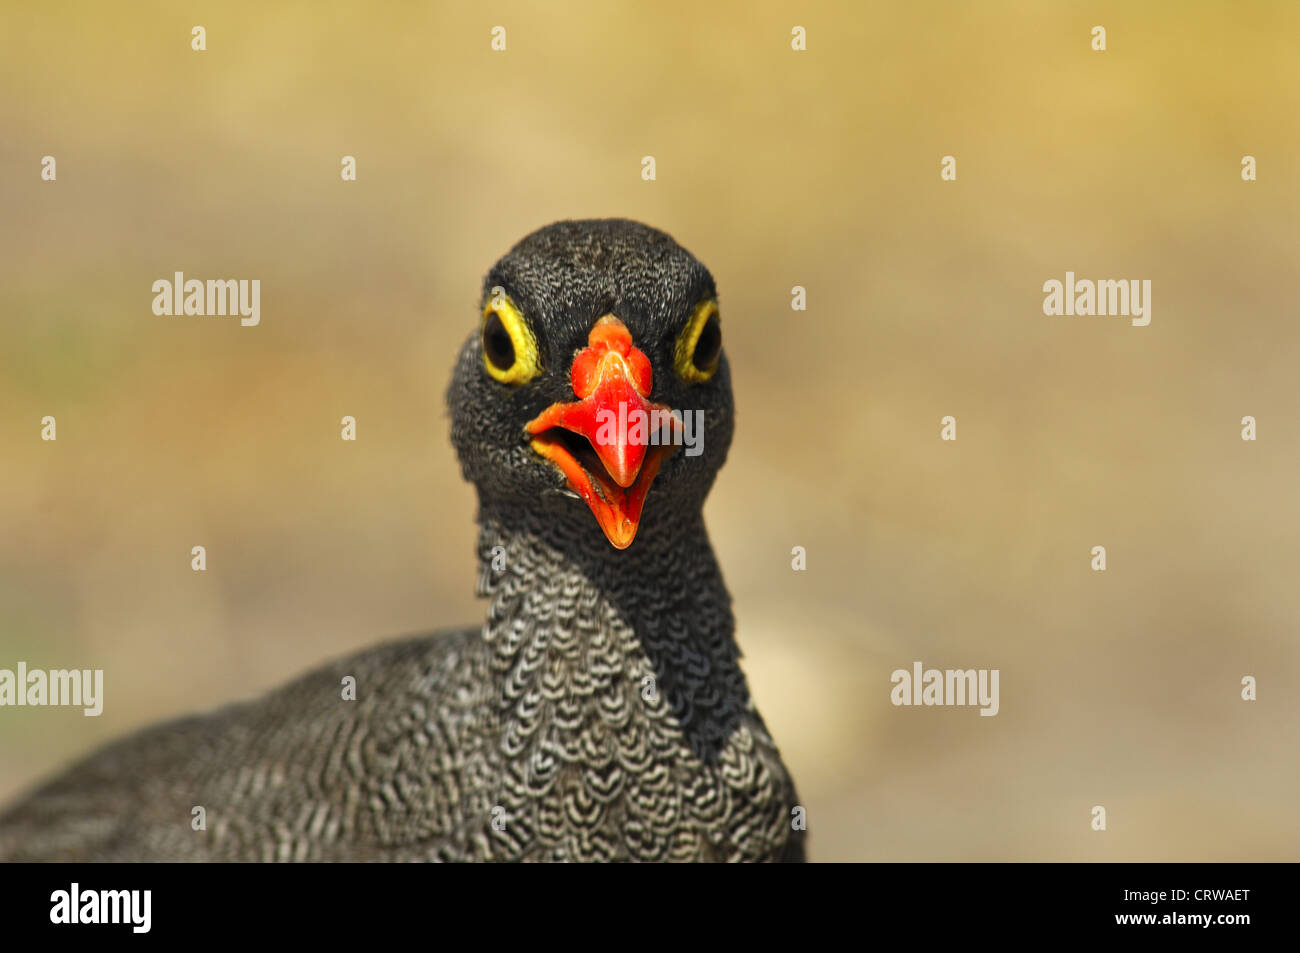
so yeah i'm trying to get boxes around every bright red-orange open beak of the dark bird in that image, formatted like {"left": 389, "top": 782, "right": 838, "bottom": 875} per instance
{"left": 524, "top": 315, "right": 680, "bottom": 549}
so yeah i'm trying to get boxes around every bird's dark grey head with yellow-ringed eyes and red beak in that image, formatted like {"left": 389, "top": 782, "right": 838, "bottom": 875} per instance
{"left": 447, "top": 220, "right": 732, "bottom": 550}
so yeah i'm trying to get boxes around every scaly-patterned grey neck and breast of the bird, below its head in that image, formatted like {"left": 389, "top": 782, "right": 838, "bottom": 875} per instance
{"left": 478, "top": 510, "right": 794, "bottom": 861}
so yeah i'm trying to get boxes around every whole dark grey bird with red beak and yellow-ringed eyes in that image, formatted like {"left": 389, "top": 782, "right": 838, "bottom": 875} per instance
{"left": 0, "top": 218, "right": 806, "bottom": 862}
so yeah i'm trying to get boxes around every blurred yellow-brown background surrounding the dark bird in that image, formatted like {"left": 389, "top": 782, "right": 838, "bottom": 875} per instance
{"left": 0, "top": 0, "right": 1300, "bottom": 861}
